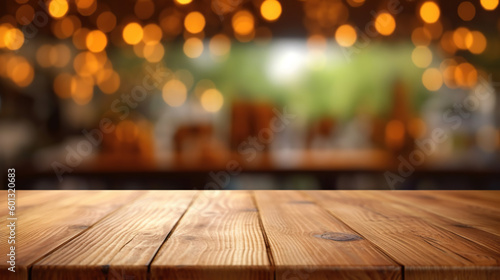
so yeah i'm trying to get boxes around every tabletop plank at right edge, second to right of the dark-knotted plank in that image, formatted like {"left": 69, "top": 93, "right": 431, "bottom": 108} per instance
{"left": 387, "top": 191, "right": 500, "bottom": 236}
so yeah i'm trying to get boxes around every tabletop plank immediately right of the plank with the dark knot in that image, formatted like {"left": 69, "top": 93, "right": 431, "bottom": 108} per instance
{"left": 308, "top": 191, "right": 500, "bottom": 280}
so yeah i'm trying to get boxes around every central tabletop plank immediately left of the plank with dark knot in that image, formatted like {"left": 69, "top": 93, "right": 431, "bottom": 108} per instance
{"left": 151, "top": 191, "right": 273, "bottom": 280}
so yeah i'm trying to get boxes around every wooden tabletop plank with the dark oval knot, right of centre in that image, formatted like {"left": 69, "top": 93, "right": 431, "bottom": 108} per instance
{"left": 255, "top": 191, "right": 401, "bottom": 280}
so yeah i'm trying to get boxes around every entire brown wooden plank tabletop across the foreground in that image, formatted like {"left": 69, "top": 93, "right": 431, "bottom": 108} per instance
{"left": 0, "top": 191, "right": 500, "bottom": 280}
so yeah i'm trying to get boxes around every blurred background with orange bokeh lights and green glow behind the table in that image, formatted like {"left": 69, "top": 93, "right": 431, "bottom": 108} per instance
{"left": 0, "top": 0, "right": 500, "bottom": 189}
